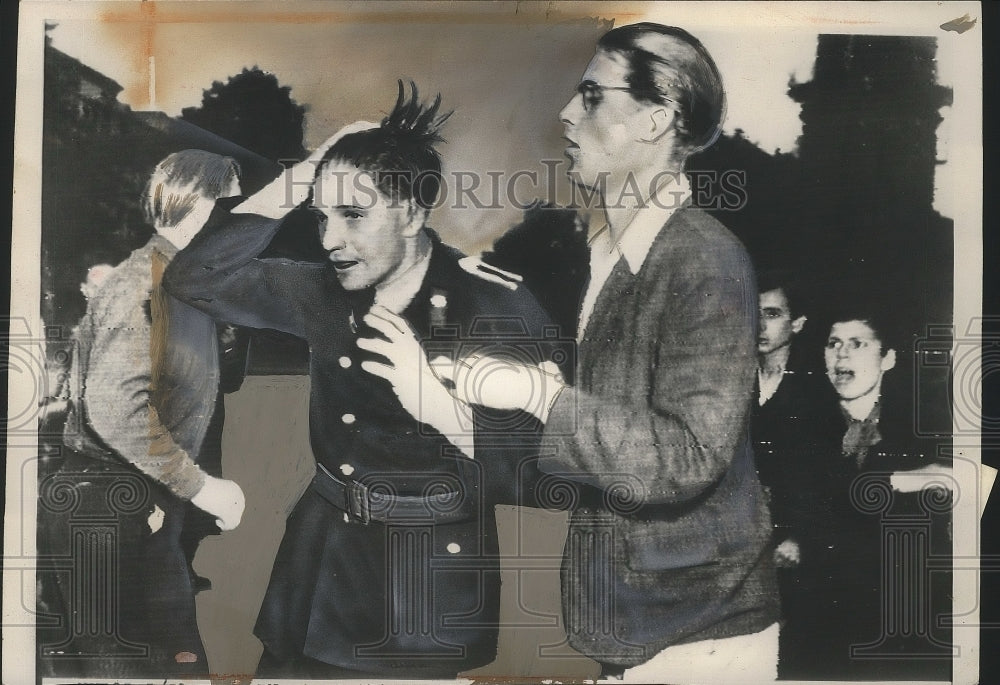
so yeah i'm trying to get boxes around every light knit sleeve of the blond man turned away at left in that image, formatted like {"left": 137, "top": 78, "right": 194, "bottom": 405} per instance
{"left": 85, "top": 285, "right": 205, "bottom": 499}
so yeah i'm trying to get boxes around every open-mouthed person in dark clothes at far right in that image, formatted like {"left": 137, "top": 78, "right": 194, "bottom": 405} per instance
{"left": 783, "top": 304, "right": 952, "bottom": 680}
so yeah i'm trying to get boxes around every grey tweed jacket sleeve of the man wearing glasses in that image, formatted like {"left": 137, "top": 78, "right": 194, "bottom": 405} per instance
{"left": 540, "top": 250, "right": 757, "bottom": 504}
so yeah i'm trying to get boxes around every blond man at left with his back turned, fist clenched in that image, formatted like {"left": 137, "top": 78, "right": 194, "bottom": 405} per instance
{"left": 39, "top": 150, "right": 244, "bottom": 678}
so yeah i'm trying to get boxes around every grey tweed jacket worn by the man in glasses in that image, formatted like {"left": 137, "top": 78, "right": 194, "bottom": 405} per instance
{"left": 539, "top": 208, "right": 778, "bottom": 665}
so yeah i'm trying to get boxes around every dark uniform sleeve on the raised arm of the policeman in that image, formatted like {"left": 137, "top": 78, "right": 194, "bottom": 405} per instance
{"left": 163, "top": 210, "right": 312, "bottom": 337}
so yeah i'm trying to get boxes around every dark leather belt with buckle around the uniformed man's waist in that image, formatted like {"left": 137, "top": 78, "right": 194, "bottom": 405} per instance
{"left": 312, "top": 464, "right": 475, "bottom": 524}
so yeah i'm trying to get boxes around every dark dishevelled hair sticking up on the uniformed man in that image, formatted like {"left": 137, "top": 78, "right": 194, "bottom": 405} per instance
{"left": 317, "top": 81, "right": 452, "bottom": 209}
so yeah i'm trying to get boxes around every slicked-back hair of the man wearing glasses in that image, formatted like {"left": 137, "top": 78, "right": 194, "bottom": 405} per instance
{"left": 597, "top": 22, "right": 726, "bottom": 155}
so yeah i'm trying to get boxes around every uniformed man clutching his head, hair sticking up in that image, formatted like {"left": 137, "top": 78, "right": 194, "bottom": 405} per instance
{"left": 164, "top": 83, "right": 555, "bottom": 678}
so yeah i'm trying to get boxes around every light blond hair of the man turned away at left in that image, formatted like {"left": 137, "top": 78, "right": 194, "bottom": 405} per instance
{"left": 142, "top": 150, "right": 240, "bottom": 228}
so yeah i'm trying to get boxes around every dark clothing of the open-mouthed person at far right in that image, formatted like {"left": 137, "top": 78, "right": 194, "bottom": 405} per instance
{"left": 783, "top": 384, "right": 951, "bottom": 680}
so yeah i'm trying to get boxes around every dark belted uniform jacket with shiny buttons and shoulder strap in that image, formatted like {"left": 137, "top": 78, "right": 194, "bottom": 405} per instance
{"left": 164, "top": 207, "right": 548, "bottom": 677}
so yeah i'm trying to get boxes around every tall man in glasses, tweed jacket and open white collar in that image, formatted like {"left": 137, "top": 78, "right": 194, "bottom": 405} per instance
{"left": 438, "top": 23, "right": 778, "bottom": 682}
